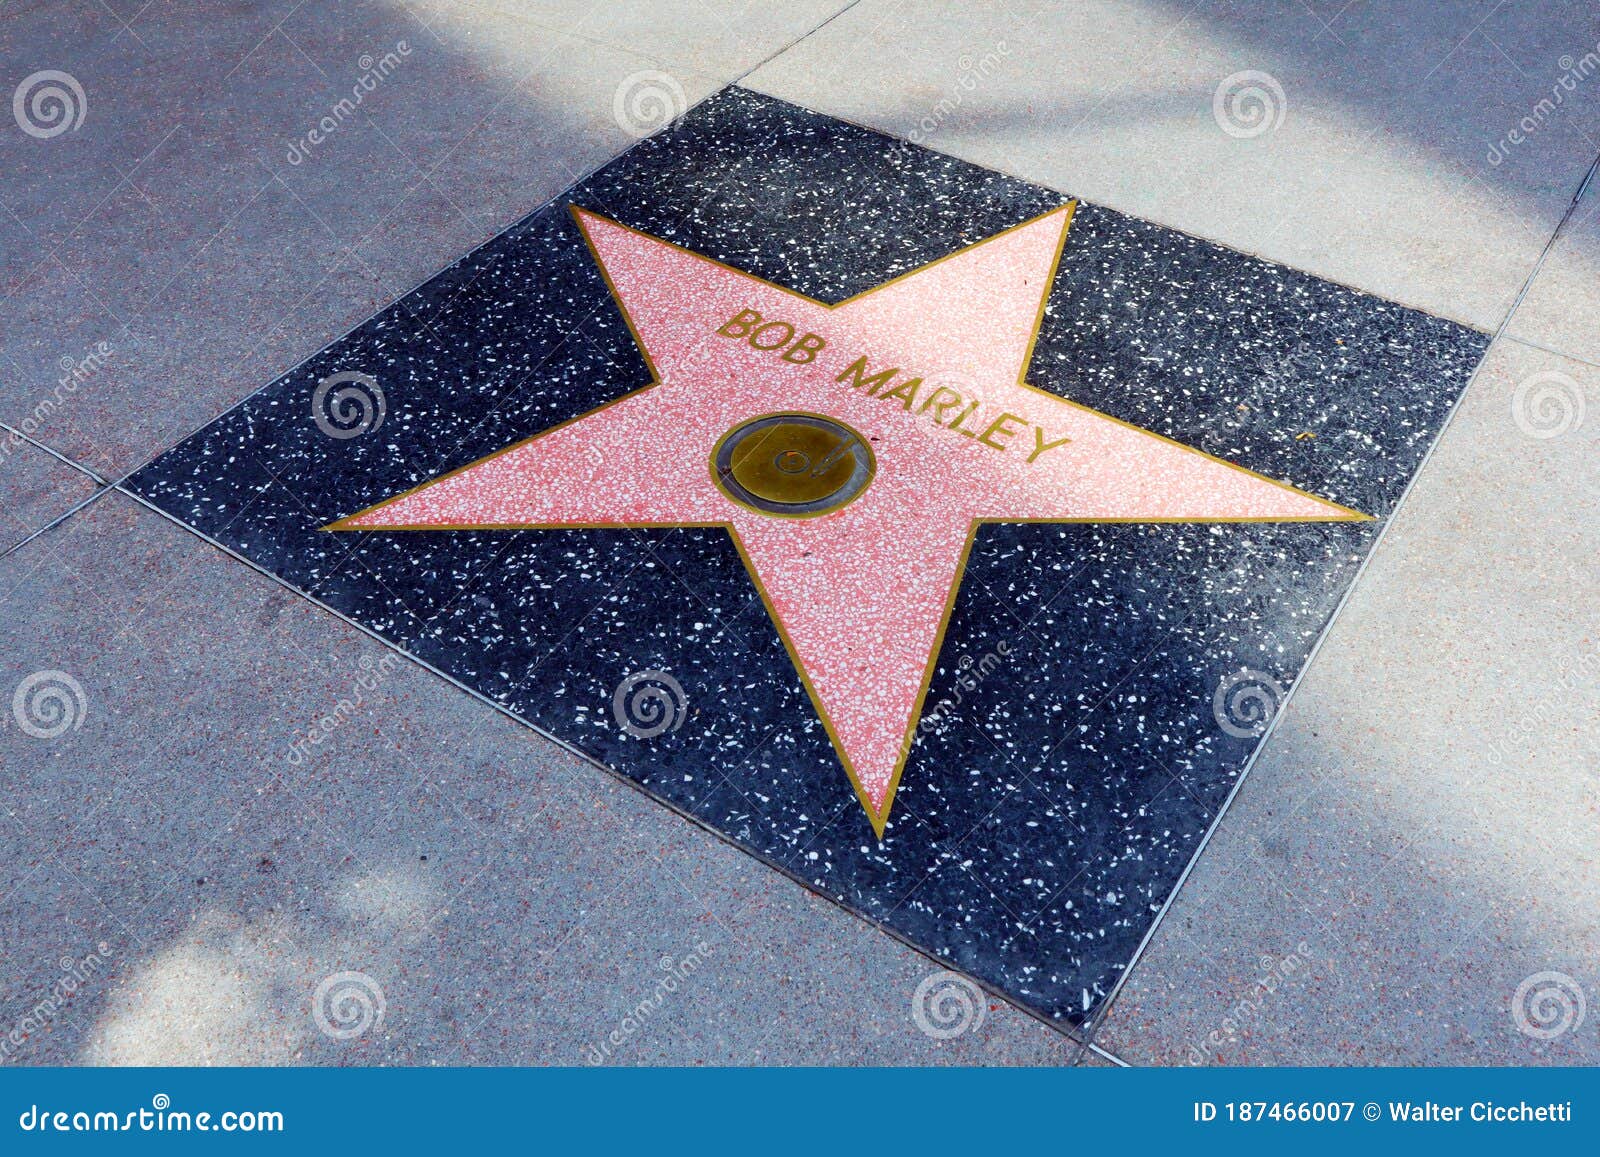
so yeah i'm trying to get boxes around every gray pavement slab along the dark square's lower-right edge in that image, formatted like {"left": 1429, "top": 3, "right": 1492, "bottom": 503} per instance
{"left": 1096, "top": 341, "right": 1600, "bottom": 1064}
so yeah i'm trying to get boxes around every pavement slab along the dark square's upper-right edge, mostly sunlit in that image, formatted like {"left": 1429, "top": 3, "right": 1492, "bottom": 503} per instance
{"left": 744, "top": 0, "right": 1600, "bottom": 330}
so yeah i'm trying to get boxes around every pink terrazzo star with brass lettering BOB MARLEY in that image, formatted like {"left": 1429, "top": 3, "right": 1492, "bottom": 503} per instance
{"left": 334, "top": 205, "right": 1365, "bottom": 837}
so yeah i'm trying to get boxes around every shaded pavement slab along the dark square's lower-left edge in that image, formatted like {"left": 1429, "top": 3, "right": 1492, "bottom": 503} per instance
{"left": 0, "top": 494, "right": 1082, "bottom": 1064}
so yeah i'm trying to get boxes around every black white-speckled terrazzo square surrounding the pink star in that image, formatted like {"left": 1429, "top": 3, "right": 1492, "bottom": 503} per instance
{"left": 124, "top": 90, "right": 1486, "bottom": 1021}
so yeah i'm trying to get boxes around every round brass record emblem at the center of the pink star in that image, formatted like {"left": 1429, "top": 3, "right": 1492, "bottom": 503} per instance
{"left": 710, "top": 413, "right": 877, "bottom": 518}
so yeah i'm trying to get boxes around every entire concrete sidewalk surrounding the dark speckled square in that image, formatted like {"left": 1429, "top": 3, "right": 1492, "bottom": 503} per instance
{"left": 0, "top": 0, "right": 1600, "bottom": 1064}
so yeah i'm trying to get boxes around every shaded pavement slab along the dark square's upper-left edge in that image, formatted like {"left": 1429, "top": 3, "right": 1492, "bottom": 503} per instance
{"left": 0, "top": 0, "right": 717, "bottom": 477}
